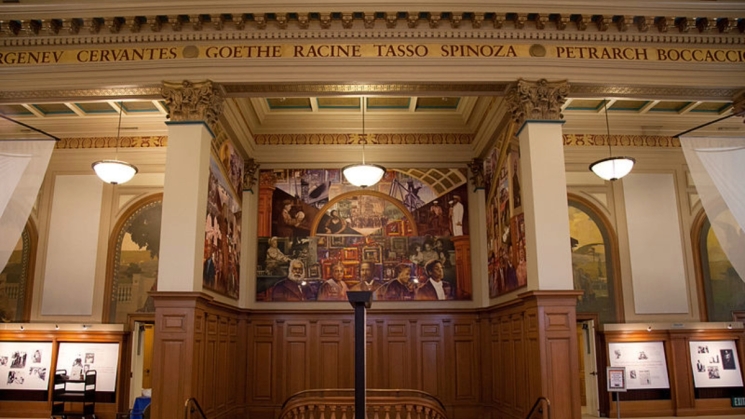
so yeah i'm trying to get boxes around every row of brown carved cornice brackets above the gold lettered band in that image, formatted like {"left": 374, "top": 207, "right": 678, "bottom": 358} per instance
{"left": 0, "top": 12, "right": 745, "bottom": 38}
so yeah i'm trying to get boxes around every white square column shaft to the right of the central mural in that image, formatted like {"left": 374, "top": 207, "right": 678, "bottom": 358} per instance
{"left": 518, "top": 120, "right": 574, "bottom": 290}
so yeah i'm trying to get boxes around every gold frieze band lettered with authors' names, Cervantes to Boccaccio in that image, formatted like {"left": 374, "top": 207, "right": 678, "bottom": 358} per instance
{"left": 0, "top": 42, "right": 745, "bottom": 66}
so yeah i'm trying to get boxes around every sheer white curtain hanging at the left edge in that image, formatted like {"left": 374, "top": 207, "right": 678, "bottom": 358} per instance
{"left": 0, "top": 140, "right": 55, "bottom": 271}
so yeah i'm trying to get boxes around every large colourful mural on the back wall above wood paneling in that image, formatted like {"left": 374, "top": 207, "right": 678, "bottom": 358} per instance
{"left": 256, "top": 169, "right": 471, "bottom": 301}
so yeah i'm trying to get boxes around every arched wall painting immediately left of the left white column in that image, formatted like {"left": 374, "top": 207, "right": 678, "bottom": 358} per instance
{"left": 109, "top": 199, "right": 163, "bottom": 323}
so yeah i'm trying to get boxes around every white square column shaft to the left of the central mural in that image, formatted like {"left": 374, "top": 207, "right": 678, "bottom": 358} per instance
{"left": 158, "top": 122, "right": 213, "bottom": 291}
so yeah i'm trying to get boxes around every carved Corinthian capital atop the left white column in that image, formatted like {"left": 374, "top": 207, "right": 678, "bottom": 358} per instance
{"left": 161, "top": 80, "right": 225, "bottom": 127}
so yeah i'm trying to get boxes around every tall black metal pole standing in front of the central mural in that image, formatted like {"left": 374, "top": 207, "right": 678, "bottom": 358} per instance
{"left": 347, "top": 291, "right": 372, "bottom": 419}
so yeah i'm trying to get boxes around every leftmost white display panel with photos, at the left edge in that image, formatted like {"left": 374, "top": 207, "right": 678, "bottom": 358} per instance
{"left": 0, "top": 342, "right": 53, "bottom": 390}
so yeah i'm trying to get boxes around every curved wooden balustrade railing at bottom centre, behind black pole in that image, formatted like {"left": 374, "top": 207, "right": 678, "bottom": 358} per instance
{"left": 279, "top": 389, "right": 447, "bottom": 419}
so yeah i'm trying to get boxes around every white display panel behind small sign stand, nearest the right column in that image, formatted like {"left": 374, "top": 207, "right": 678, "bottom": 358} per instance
{"left": 608, "top": 342, "right": 670, "bottom": 390}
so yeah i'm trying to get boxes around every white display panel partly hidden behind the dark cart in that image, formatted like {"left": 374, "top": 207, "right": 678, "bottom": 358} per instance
{"left": 57, "top": 342, "right": 119, "bottom": 391}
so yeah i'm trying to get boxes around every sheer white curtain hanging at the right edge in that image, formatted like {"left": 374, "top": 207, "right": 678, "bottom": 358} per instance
{"left": 680, "top": 137, "right": 745, "bottom": 280}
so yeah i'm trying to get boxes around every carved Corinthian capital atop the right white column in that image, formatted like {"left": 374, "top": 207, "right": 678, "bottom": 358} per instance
{"left": 506, "top": 79, "right": 569, "bottom": 125}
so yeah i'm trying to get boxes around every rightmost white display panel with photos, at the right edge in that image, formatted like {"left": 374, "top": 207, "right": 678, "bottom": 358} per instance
{"left": 689, "top": 340, "right": 742, "bottom": 388}
